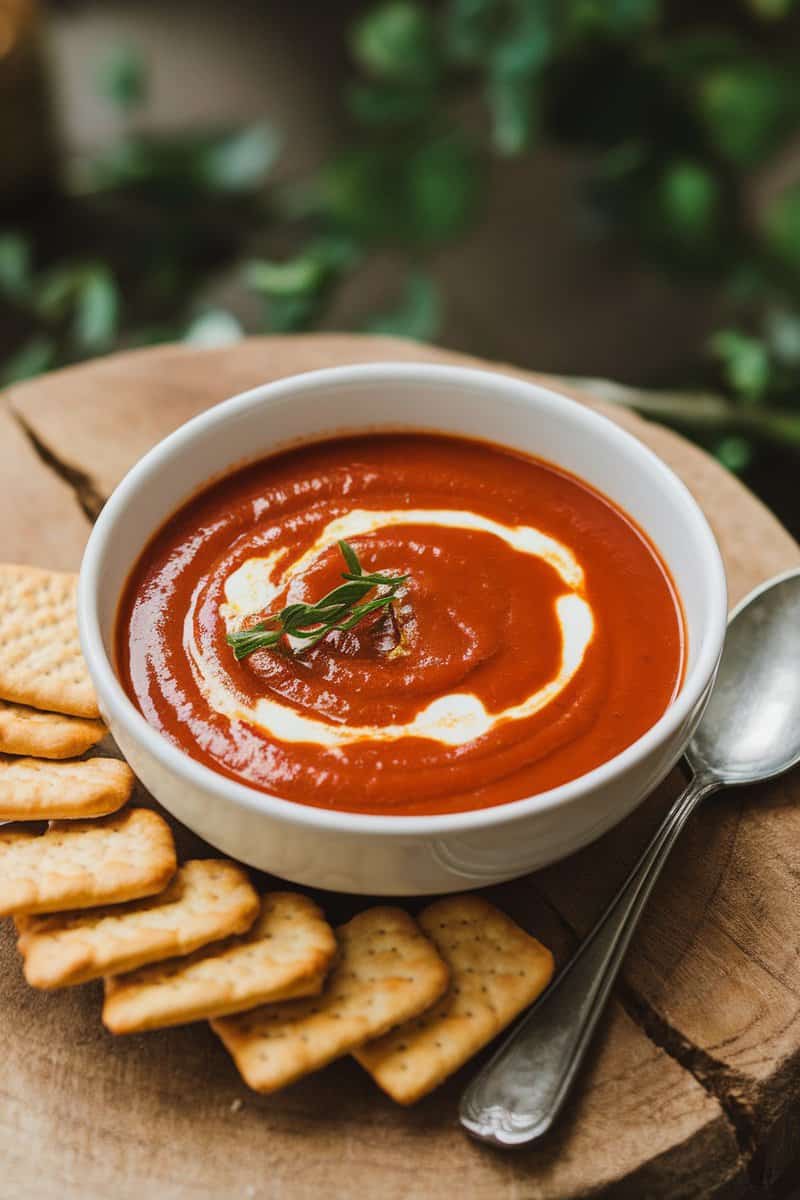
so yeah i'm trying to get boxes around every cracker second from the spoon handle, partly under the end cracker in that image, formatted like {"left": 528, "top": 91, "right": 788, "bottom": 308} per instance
{"left": 211, "top": 907, "right": 447, "bottom": 1092}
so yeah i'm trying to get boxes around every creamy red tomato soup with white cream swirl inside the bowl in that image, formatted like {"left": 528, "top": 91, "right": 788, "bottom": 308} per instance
{"left": 118, "top": 434, "right": 684, "bottom": 815}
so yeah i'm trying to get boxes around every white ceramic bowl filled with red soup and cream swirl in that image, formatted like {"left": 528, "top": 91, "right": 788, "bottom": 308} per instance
{"left": 79, "top": 364, "right": 726, "bottom": 894}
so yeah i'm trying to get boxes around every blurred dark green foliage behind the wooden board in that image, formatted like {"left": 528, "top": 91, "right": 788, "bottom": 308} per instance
{"left": 0, "top": 0, "right": 800, "bottom": 469}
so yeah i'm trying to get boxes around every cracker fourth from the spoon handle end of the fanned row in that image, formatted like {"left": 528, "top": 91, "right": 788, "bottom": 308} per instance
{"left": 17, "top": 858, "right": 259, "bottom": 988}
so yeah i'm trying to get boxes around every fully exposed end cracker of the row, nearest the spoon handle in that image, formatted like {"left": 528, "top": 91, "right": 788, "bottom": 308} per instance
{"left": 355, "top": 895, "right": 553, "bottom": 1104}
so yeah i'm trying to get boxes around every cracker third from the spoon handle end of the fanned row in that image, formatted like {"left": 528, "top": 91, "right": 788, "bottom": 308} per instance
{"left": 103, "top": 892, "right": 336, "bottom": 1033}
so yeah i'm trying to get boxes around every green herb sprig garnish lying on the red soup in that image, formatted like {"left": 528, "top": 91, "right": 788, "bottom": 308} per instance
{"left": 227, "top": 541, "right": 408, "bottom": 661}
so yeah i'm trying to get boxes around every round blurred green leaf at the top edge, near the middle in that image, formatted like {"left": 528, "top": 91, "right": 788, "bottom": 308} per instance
{"left": 350, "top": 0, "right": 439, "bottom": 83}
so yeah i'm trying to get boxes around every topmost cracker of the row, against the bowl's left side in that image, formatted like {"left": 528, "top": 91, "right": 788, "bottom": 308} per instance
{"left": 0, "top": 563, "right": 100, "bottom": 718}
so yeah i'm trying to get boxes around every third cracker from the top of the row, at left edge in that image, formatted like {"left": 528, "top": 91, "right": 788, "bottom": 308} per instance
{"left": 0, "top": 755, "right": 134, "bottom": 821}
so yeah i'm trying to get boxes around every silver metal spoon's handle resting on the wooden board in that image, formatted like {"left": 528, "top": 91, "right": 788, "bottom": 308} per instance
{"left": 459, "top": 775, "right": 720, "bottom": 1146}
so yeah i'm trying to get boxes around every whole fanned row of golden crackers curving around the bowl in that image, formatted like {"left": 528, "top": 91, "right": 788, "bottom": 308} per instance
{"left": 0, "top": 565, "right": 553, "bottom": 1104}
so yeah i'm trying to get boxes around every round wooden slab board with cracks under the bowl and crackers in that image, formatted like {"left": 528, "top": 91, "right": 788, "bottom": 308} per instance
{"left": 0, "top": 336, "right": 800, "bottom": 1200}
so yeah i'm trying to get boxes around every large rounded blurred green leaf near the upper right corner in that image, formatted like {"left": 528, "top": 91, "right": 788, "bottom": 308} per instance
{"left": 697, "top": 62, "right": 800, "bottom": 167}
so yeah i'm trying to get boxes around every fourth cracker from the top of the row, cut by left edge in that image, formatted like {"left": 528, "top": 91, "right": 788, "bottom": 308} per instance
{"left": 0, "top": 809, "right": 176, "bottom": 917}
